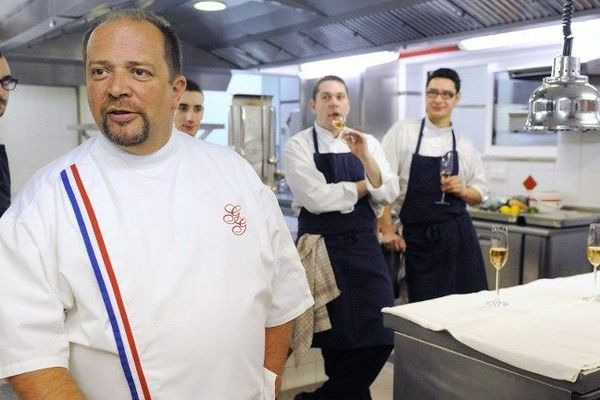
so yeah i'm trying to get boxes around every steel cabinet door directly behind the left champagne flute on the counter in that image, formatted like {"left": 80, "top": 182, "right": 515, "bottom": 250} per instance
{"left": 475, "top": 227, "right": 523, "bottom": 289}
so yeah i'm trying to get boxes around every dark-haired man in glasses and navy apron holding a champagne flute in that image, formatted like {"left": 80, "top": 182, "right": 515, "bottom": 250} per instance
{"left": 379, "top": 68, "right": 488, "bottom": 302}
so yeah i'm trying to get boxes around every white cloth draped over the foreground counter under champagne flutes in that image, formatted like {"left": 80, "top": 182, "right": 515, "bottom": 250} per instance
{"left": 382, "top": 274, "right": 600, "bottom": 382}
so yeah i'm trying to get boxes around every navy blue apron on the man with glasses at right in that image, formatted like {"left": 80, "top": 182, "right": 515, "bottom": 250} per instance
{"left": 400, "top": 119, "right": 487, "bottom": 302}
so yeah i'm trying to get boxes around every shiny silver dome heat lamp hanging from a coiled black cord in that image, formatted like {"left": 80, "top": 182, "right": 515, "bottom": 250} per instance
{"left": 525, "top": 0, "right": 600, "bottom": 132}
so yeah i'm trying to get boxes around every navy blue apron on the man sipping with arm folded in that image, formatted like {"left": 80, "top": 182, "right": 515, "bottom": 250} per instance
{"left": 298, "top": 128, "right": 394, "bottom": 349}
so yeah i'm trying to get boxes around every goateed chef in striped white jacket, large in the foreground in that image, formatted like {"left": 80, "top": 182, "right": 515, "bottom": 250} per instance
{"left": 0, "top": 10, "right": 313, "bottom": 400}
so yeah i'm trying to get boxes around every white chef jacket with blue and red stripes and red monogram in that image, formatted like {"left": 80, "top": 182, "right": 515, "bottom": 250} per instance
{"left": 0, "top": 132, "right": 313, "bottom": 400}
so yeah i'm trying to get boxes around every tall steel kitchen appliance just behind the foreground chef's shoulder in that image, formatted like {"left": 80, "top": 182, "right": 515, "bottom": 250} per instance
{"left": 229, "top": 94, "right": 283, "bottom": 191}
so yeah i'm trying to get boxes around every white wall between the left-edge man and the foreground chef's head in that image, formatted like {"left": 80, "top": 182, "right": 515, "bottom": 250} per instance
{"left": 0, "top": 85, "right": 77, "bottom": 198}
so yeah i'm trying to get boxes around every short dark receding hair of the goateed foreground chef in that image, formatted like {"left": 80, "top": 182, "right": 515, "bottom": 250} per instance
{"left": 83, "top": 9, "right": 182, "bottom": 80}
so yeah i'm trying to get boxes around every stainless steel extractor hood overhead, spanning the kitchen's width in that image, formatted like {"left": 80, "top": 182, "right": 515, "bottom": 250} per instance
{"left": 0, "top": 0, "right": 600, "bottom": 74}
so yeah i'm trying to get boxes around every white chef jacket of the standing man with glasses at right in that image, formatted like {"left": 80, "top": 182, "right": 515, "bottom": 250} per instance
{"left": 382, "top": 117, "right": 488, "bottom": 210}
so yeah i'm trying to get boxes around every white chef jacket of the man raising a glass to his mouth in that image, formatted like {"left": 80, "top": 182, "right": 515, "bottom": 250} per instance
{"left": 283, "top": 122, "right": 398, "bottom": 216}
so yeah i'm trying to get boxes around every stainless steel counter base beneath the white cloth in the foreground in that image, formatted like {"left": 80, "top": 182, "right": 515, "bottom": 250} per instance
{"left": 383, "top": 314, "right": 600, "bottom": 400}
